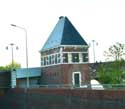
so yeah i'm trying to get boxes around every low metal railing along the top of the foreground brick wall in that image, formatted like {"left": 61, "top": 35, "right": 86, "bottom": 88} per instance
{"left": 24, "top": 84, "right": 125, "bottom": 90}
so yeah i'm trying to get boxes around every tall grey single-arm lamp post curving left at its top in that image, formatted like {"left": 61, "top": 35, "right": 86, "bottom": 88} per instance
{"left": 11, "top": 24, "right": 29, "bottom": 87}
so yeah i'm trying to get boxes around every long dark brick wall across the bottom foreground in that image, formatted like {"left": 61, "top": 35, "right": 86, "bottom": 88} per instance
{"left": 0, "top": 88, "right": 125, "bottom": 109}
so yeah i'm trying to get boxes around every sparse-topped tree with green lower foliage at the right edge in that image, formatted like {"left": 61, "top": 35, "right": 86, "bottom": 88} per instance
{"left": 97, "top": 42, "right": 125, "bottom": 84}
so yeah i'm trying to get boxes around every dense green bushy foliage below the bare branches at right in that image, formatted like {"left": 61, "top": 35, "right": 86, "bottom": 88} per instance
{"left": 97, "top": 61, "right": 125, "bottom": 84}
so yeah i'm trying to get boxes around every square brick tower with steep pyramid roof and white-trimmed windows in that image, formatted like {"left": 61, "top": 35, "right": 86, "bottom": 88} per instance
{"left": 40, "top": 16, "right": 89, "bottom": 86}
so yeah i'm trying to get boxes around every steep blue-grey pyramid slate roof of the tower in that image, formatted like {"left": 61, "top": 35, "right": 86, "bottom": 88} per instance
{"left": 41, "top": 16, "right": 87, "bottom": 51}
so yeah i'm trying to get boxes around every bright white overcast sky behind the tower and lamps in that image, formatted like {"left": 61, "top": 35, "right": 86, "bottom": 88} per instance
{"left": 0, "top": 0, "right": 125, "bottom": 67}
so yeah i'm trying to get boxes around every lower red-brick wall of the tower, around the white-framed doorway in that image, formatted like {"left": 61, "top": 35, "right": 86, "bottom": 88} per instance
{"left": 41, "top": 64, "right": 90, "bottom": 85}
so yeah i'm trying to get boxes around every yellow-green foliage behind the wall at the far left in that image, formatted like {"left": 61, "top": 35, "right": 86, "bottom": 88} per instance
{"left": 0, "top": 62, "right": 21, "bottom": 71}
